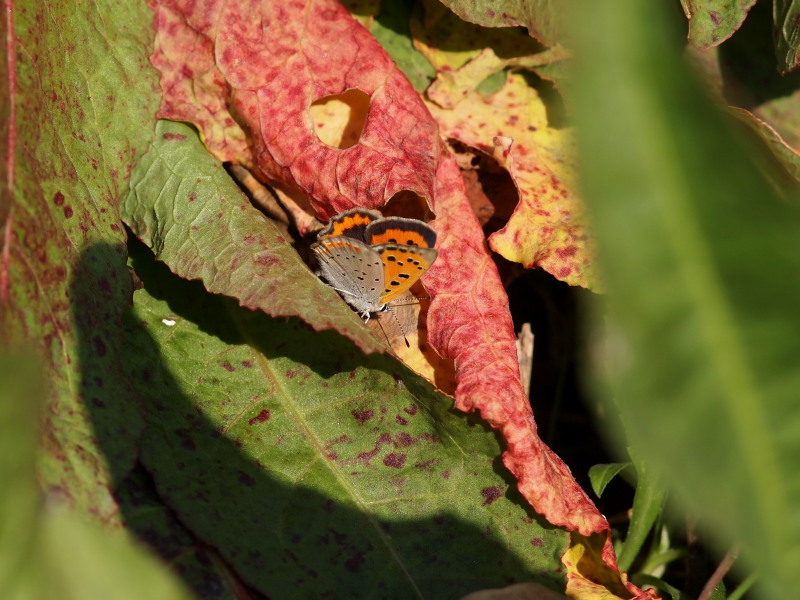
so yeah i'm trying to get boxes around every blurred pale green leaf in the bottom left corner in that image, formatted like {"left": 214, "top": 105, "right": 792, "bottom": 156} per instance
{"left": 0, "top": 356, "right": 190, "bottom": 600}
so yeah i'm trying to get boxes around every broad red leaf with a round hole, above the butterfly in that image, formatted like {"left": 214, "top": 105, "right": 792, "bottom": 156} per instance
{"left": 152, "top": 0, "right": 439, "bottom": 217}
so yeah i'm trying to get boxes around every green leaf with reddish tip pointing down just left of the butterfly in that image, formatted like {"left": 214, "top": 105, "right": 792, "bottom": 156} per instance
{"left": 122, "top": 120, "right": 384, "bottom": 352}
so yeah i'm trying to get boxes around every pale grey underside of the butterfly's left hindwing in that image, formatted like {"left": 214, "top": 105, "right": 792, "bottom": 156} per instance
{"left": 311, "top": 236, "right": 385, "bottom": 315}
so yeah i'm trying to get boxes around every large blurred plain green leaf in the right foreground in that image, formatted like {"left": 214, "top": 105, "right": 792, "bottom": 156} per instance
{"left": 573, "top": 1, "right": 800, "bottom": 598}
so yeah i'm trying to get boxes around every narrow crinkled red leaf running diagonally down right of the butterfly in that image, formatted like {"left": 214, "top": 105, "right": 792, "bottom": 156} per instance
{"left": 424, "top": 156, "right": 608, "bottom": 535}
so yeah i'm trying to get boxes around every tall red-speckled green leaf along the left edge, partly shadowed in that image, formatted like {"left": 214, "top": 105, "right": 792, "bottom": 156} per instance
{"left": 0, "top": 0, "right": 159, "bottom": 523}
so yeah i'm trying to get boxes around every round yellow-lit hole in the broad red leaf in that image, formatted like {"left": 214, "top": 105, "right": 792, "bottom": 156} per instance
{"left": 309, "top": 89, "right": 369, "bottom": 150}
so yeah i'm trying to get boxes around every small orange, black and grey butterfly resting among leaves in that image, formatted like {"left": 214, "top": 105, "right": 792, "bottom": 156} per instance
{"left": 311, "top": 208, "right": 438, "bottom": 320}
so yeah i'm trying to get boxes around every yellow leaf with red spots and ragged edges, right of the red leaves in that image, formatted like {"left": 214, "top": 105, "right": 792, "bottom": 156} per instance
{"left": 429, "top": 74, "right": 599, "bottom": 288}
